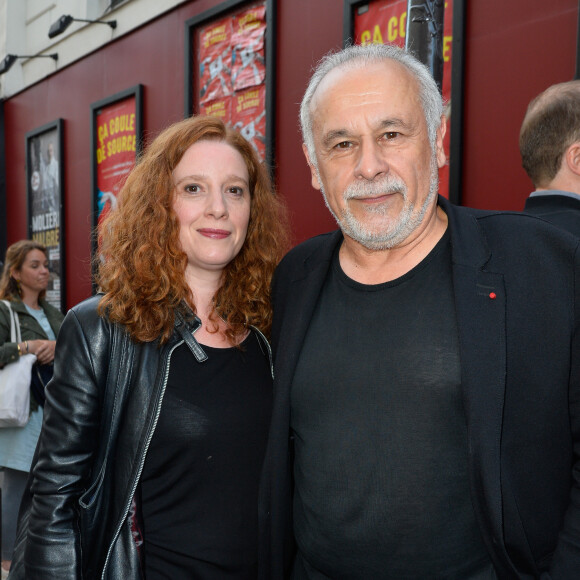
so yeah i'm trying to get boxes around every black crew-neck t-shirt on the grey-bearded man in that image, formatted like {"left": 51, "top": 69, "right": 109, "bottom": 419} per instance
{"left": 291, "top": 233, "right": 493, "bottom": 580}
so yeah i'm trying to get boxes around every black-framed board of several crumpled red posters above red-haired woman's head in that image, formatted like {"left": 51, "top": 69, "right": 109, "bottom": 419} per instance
{"left": 185, "top": 0, "right": 275, "bottom": 168}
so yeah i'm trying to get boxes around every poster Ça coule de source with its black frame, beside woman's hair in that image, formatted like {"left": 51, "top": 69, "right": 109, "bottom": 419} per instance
{"left": 91, "top": 85, "right": 143, "bottom": 270}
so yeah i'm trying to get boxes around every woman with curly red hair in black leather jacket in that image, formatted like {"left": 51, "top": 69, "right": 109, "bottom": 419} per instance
{"left": 10, "top": 117, "right": 288, "bottom": 580}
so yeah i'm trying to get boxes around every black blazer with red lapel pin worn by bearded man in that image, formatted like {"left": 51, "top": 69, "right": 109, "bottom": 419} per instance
{"left": 260, "top": 198, "right": 580, "bottom": 580}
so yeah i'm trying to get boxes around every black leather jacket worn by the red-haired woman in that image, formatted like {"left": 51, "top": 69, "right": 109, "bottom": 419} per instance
{"left": 10, "top": 297, "right": 271, "bottom": 580}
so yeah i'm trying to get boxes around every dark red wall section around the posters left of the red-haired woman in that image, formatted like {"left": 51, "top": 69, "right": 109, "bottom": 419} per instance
{"left": 5, "top": 0, "right": 240, "bottom": 307}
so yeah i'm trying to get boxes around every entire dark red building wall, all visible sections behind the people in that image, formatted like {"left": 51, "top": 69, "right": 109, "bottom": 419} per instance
{"left": 5, "top": 0, "right": 578, "bottom": 306}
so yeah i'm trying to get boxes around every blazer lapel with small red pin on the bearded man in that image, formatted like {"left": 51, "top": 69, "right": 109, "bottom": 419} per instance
{"left": 440, "top": 200, "right": 513, "bottom": 570}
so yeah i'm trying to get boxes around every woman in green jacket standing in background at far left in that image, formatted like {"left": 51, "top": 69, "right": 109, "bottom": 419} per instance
{"left": 0, "top": 240, "right": 63, "bottom": 578}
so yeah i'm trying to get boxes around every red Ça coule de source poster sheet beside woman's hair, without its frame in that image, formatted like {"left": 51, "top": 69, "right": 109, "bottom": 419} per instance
{"left": 95, "top": 97, "right": 137, "bottom": 230}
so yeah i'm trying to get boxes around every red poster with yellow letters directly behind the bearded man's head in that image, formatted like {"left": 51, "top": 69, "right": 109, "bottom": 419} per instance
{"left": 354, "top": 0, "right": 453, "bottom": 197}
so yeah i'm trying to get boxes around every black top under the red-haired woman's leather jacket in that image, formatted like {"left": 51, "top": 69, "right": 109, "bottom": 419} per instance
{"left": 140, "top": 331, "right": 272, "bottom": 580}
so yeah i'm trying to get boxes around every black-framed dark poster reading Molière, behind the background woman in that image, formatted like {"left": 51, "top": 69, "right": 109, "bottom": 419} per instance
{"left": 26, "top": 119, "right": 66, "bottom": 312}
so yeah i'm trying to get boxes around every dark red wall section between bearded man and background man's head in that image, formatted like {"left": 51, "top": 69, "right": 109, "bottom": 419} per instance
{"left": 462, "top": 0, "right": 578, "bottom": 210}
